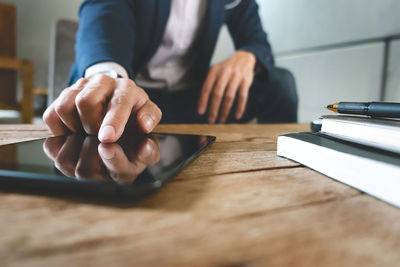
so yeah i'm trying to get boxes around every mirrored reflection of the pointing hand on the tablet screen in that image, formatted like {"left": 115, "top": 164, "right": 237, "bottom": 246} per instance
{"left": 43, "top": 135, "right": 160, "bottom": 184}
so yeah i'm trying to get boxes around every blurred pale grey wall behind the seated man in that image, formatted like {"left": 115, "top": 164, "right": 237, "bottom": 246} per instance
{"left": 1, "top": 0, "right": 400, "bottom": 122}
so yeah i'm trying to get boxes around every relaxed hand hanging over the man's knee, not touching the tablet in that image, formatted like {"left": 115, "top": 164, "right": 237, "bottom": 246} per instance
{"left": 198, "top": 51, "right": 256, "bottom": 123}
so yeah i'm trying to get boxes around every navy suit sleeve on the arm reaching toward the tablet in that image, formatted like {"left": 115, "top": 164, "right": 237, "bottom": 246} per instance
{"left": 75, "top": 0, "right": 135, "bottom": 77}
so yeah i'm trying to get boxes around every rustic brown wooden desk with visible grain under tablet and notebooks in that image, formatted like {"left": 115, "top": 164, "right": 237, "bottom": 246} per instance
{"left": 0, "top": 125, "right": 400, "bottom": 266}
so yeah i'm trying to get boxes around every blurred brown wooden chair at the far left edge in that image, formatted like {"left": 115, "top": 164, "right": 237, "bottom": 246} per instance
{"left": 0, "top": 3, "right": 34, "bottom": 123}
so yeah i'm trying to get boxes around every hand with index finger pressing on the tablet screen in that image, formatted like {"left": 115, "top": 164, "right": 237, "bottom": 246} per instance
{"left": 43, "top": 74, "right": 161, "bottom": 143}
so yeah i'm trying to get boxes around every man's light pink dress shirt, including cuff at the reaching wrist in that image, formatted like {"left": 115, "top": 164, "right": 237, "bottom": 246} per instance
{"left": 85, "top": 0, "right": 207, "bottom": 91}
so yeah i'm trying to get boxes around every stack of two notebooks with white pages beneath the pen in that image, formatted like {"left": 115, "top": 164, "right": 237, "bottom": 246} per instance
{"left": 277, "top": 115, "right": 400, "bottom": 207}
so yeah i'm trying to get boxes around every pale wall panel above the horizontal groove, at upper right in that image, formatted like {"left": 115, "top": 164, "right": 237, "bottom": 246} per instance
{"left": 258, "top": 0, "right": 400, "bottom": 53}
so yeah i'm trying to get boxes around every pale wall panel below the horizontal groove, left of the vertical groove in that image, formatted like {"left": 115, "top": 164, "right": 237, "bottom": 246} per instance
{"left": 277, "top": 42, "right": 384, "bottom": 122}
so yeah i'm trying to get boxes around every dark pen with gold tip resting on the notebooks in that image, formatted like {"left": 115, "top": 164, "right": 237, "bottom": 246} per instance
{"left": 326, "top": 102, "right": 400, "bottom": 118}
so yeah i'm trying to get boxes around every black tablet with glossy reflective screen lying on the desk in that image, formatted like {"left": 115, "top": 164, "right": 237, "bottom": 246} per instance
{"left": 0, "top": 133, "right": 215, "bottom": 204}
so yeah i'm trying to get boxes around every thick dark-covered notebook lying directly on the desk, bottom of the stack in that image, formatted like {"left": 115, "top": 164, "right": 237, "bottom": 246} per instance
{"left": 277, "top": 133, "right": 400, "bottom": 207}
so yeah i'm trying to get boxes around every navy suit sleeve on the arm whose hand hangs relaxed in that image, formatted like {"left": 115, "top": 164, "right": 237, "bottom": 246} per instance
{"left": 227, "top": 0, "right": 274, "bottom": 75}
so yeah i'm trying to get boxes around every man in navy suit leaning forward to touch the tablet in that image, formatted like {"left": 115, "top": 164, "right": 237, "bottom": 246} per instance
{"left": 43, "top": 0, "right": 297, "bottom": 142}
